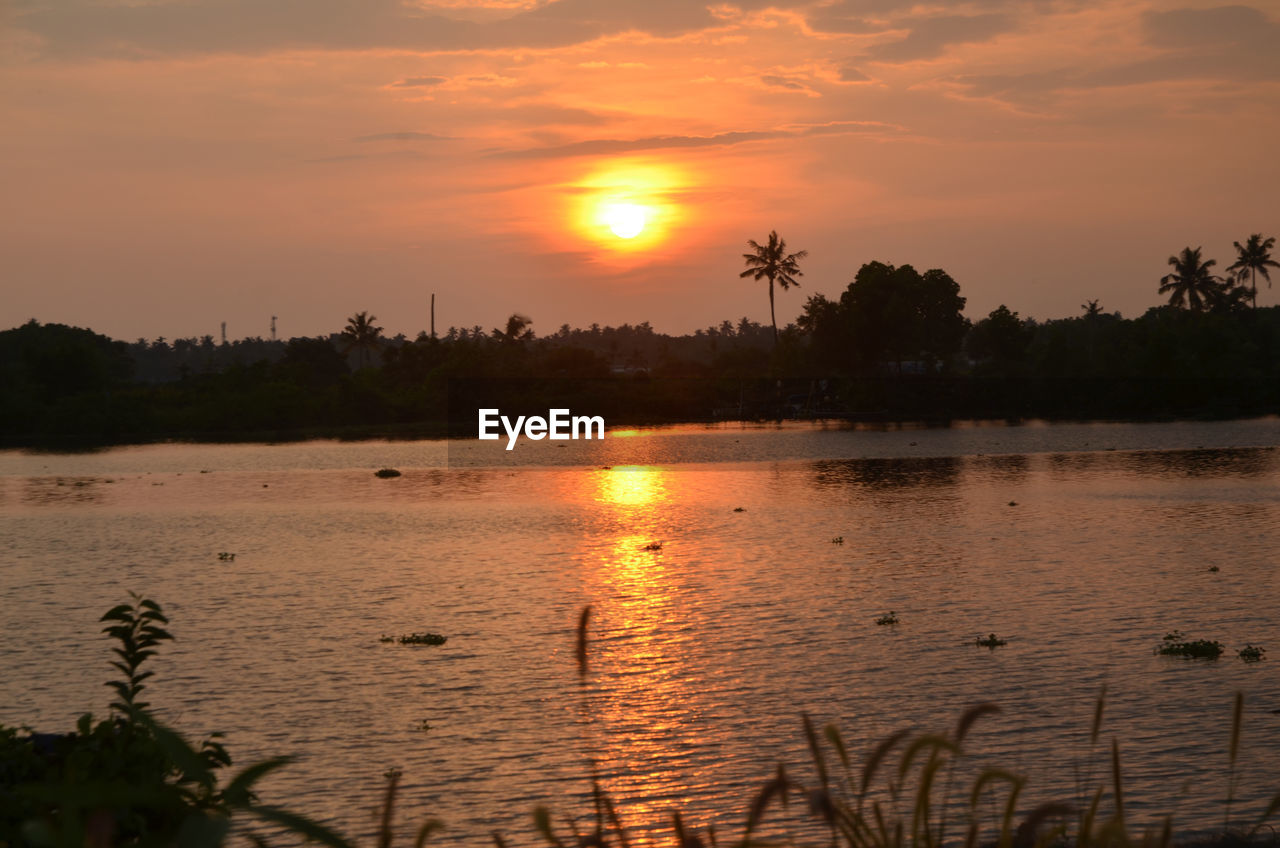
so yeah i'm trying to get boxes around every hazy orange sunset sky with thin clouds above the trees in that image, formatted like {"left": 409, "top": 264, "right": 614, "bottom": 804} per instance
{"left": 0, "top": 0, "right": 1280, "bottom": 339}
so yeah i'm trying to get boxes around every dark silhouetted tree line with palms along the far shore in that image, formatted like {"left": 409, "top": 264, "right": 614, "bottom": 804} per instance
{"left": 0, "top": 232, "right": 1280, "bottom": 444}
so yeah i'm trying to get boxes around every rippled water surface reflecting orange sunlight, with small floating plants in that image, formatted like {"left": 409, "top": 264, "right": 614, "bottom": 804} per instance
{"left": 0, "top": 420, "right": 1280, "bottom": 844}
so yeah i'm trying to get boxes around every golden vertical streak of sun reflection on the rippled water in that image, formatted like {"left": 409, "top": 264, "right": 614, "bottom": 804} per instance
{"left": 581, "top": 465, "right": 709, "bottom": 845}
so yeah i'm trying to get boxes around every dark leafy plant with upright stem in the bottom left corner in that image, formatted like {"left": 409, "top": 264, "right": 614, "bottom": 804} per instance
{"left": 0, "top": 594, "right": 347, "bottom": 848}
